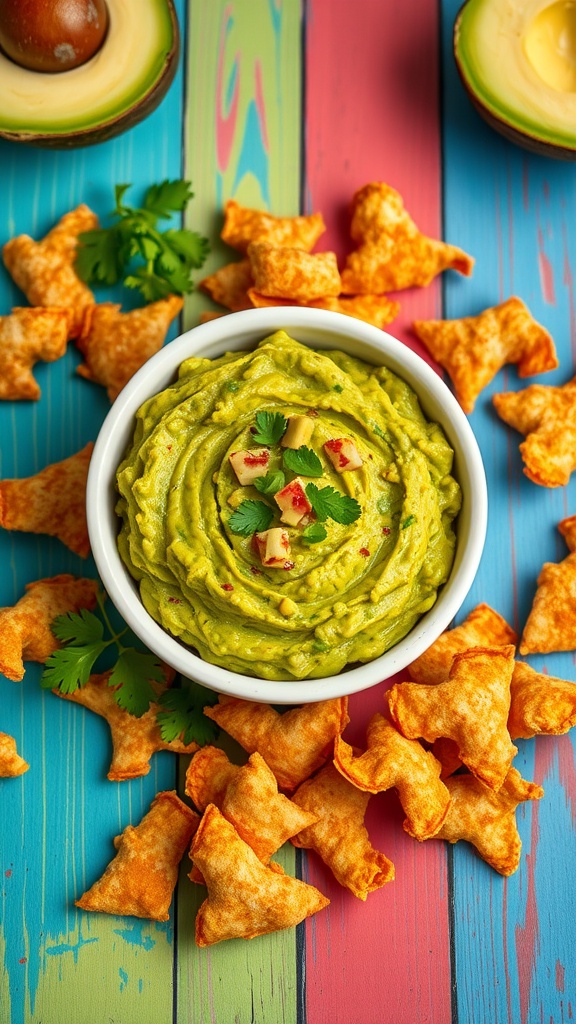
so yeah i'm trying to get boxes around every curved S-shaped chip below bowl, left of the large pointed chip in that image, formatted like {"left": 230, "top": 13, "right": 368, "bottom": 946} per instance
{"left": 334, "top": 713, "right": 450, "bottom": 840}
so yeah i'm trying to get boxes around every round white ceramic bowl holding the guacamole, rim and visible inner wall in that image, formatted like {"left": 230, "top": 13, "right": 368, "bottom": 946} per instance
{"left": 86, "top": 306, "right": 488, "bottom": 705}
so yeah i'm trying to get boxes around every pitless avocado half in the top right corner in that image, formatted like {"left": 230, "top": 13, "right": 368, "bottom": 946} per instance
{"left": 454, "top": 0, "right": 576, "bottom": 160}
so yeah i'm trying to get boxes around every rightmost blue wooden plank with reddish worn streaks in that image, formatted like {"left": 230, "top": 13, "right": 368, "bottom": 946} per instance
{"left": 443, "top": 0, "right": 576, "bottom": 1024}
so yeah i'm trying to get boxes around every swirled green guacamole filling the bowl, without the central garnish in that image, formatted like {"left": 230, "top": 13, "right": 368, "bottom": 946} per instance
{"left": 117, "top": 331, "right": 460, "bottom": 679}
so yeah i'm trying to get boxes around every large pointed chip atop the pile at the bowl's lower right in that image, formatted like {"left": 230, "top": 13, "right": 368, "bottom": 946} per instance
{"left": 388, "top": 644, "right": 518, "bottom": 791}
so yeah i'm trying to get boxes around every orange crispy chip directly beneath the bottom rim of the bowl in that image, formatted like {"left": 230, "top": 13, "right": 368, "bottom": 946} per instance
{"left": 204, "top": 696, "right": 349, "bottom": 790}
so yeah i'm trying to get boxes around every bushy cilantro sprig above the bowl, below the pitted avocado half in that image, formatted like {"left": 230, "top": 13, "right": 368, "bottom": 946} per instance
{"left": 76, "top": 179, "right": 209, "bottom": 302}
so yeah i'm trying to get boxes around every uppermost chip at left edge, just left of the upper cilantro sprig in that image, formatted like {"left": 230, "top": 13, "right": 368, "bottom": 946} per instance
{"left": 2, "top": 204, "right": 98, "bottom": 338}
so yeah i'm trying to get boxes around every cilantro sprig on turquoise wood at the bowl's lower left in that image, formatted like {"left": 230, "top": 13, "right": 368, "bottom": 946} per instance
{"left": 40, "top": 594, "right": 164, "bottom": 718}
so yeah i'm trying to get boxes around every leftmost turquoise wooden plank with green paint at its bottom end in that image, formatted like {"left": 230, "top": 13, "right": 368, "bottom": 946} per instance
{"left": 0, "top": 0, "right": 184, "bottom": 1024}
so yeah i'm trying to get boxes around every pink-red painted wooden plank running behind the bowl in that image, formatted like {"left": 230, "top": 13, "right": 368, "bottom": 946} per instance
{"left": 305, "top": 0, "right": 451, "bottom": 1024}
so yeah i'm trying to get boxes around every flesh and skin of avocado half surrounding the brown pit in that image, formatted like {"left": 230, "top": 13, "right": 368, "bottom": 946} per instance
{"left": 0, "top": 0, "right": 179, "bottom": 150}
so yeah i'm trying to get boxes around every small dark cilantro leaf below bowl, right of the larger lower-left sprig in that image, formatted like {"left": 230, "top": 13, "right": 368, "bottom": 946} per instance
{"left": 156, "top": 679, "right": 218, "bottom": 746}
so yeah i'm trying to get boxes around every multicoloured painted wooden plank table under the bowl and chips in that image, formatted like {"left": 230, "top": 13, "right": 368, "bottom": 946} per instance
{"left": 0, "top": 0, "right": 576, "bottom": 1024}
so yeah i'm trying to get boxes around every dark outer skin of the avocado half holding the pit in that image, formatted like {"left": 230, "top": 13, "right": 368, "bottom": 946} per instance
{"left": 0, "top": 0, "right": 180, "bottom": 150}
